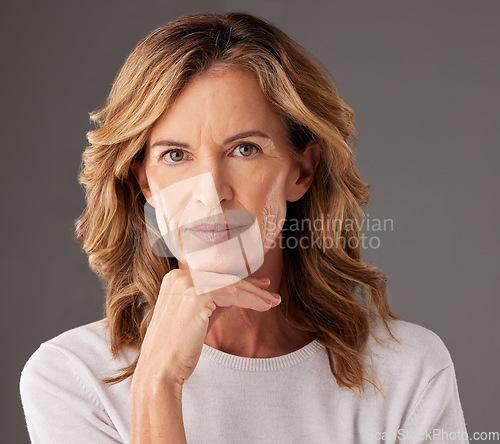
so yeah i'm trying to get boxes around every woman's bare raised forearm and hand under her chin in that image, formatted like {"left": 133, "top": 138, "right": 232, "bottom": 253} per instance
{"left": 127, "top": 269, "right": 280, "bottom": 444}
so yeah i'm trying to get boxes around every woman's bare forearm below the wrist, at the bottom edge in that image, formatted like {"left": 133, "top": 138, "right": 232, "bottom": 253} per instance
{"left": 130, "top": 372, "right": 186, "bottom": 444}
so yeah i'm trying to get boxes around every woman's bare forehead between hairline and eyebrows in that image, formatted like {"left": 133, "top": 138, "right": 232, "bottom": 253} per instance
{"left": 150, "top": 68, "right": 284, "bottom": 142}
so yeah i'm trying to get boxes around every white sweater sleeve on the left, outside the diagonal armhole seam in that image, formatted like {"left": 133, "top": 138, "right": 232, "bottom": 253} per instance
{"left": 20, "top": 344, "right": 122, "bottom": 444}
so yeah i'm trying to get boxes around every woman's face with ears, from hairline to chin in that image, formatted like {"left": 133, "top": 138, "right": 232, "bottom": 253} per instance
{"left": 133, "top": 68, "right": 313, "bottom": 276}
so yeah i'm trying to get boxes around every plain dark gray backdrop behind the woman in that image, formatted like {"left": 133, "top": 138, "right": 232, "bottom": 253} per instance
{"left": 0, "top": 0, "right": 500, "bottom": 443}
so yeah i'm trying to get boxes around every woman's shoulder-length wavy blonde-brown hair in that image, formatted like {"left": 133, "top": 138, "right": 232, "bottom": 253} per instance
{"left": 75, "top": 13, "right": 398, "bottom": 391}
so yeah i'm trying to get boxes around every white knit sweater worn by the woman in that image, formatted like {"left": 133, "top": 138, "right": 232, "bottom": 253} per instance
{"left": 20, "top": 320, "right": 468, "bottom": 444}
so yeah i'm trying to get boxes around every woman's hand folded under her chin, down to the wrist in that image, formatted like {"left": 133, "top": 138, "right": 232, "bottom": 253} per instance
{"left": 134, "top": 269, "right": 281, "bottom": 386}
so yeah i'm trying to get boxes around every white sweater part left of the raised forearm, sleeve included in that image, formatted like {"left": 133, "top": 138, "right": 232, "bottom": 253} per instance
{"left": 19, "top": 320, "right": 133, "bottom": 442}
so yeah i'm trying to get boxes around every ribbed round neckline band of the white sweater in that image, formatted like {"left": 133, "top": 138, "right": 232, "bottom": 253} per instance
{"left": 201, "top": 339, "right": 324, "bottom": 372}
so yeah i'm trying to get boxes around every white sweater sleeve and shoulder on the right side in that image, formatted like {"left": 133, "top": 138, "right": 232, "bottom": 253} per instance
{"left": 371, "top": 320, "right": 466, "bottom": 442}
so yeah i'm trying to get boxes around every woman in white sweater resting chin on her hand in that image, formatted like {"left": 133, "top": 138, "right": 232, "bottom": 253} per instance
{"left": 21, "top": 13, "right": 468, "bottom": 443}
